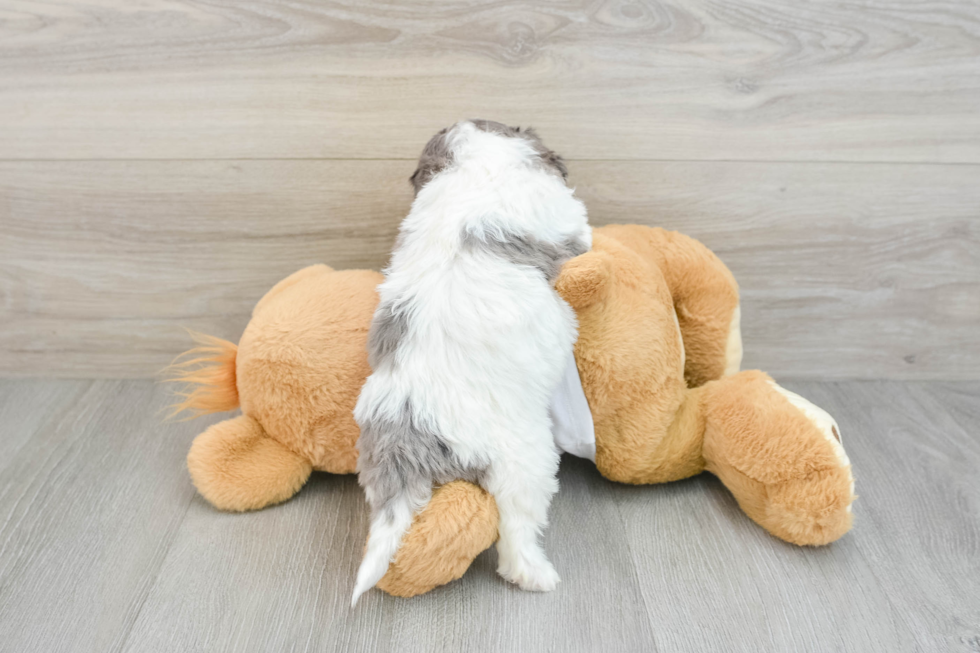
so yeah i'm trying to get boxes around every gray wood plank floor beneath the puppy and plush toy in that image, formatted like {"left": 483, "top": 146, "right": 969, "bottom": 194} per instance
{"left": 0, "top": 380, "right": 980, "bottom": 653}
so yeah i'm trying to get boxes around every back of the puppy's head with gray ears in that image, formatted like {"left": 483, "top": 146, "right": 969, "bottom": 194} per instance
{"left": 410, "top": 119, "right": 568, "bottom": 195}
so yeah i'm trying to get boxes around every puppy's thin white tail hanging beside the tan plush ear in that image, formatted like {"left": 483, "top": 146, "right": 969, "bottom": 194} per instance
{"left": 351, "top": 484, "right": 432, "bottom": 608}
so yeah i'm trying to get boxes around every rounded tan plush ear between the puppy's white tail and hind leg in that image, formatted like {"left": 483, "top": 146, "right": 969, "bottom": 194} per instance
{"left": 378, "top": 481, "right": 498, "bottom": 597}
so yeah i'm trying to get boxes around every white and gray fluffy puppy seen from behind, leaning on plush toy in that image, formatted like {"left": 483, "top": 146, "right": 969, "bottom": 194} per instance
{"left": 352, "top": 120, "right": 592, "bottom": 605}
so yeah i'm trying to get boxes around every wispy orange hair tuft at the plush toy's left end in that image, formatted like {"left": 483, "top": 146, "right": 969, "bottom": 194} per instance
{"left": 165, "top": 331, "right": 238, "bottom": 417}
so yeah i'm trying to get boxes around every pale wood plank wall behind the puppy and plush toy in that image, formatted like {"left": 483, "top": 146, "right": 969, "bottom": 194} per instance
{"left": 0, "top": 0, "right": 980, "bottom": 379}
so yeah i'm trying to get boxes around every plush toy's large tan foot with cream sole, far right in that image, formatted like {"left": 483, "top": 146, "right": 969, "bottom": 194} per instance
{"left": 703, "top": 371, "right": 854, "bottom": 545}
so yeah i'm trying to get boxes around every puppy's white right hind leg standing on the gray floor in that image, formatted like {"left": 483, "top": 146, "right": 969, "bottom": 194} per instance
{"left": 485, "top": 436, "right": 561, "bottom": 592}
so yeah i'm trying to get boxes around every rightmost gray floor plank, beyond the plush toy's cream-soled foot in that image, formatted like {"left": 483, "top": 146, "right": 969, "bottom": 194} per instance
{"left": 787, "top": 382, "right": 980, "bottom": 653}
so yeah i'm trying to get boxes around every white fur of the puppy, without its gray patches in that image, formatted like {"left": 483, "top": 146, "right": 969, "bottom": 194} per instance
{"left": 353, "top": 122, "right": 592, "bottom": 603}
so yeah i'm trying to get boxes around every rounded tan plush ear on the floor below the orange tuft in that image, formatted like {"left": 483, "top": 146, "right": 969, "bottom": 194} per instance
{"left": 187, "top": 415, "right": 313, "bottom": 512}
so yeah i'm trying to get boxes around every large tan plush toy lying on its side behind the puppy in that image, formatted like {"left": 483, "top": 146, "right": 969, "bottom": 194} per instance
{"left": 175, "top": 225, "right": 854, "bottom": 596}
